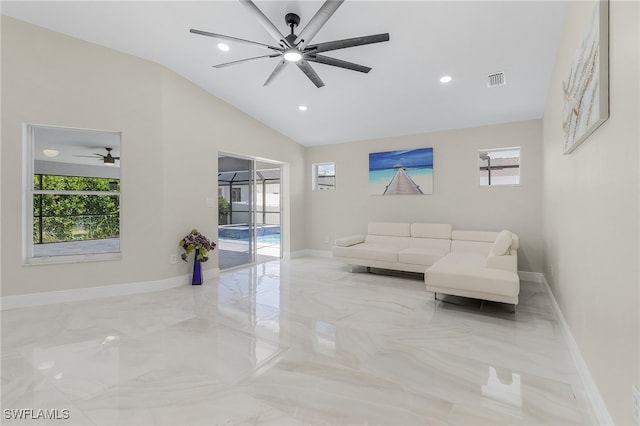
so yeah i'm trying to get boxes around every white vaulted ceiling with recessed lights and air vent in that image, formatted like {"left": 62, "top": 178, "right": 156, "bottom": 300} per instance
{"left": 2, "top": 0, "right": 566, "bottom": 146}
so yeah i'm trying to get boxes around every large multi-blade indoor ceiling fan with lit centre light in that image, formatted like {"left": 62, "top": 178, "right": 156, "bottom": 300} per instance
{"left": 189, "top": 0, "right": 389, "bottom": 88}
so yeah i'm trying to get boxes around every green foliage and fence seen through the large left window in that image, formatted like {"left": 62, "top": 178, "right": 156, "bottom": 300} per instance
{"left": 33, "top": 174, "right": 120, "bottom": 245}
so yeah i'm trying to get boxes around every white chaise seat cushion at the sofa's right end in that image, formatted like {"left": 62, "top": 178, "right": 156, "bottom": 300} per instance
{"left": 424, "top": 252, "right": 520, "bottom": 297}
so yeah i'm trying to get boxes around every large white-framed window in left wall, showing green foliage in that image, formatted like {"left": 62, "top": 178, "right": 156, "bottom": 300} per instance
{"left": 24, "top": 125, "right": 120, "bottom": 263}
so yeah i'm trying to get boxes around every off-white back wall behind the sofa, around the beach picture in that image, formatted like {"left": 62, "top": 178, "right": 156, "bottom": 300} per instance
{"left": 305, "top": 120, "right": 542, "bottom": 272}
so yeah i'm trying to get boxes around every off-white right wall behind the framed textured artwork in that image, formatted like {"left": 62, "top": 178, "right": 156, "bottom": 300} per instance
{"left": 543, "top": 1, "right": 640, "bottom": 425}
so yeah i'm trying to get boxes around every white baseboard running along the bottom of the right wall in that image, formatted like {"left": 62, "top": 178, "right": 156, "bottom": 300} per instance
{"left": 540, "top": 274, "right": 614, "bottom": 426}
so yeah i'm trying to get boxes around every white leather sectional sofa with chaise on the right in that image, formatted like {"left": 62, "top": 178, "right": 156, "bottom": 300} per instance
{"left": 332, "top": 222, "right": 520, "bottom": 305}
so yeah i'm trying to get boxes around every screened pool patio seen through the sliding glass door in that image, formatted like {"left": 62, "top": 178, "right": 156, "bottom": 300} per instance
{"left": 218, "top": 155, "right": 281, "bottom": 269}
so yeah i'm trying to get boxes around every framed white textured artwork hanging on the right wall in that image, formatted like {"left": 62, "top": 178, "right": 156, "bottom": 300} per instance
{"left": 562, "top": 0, "right": 609, "bottom": 154}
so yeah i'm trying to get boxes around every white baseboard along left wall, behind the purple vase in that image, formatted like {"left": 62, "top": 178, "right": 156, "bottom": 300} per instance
{"left": 0, "top": 268, "right": 220, "bottom": 311}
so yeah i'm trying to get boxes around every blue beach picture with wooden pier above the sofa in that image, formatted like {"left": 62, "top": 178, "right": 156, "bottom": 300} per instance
{"left": 369, "top": 148, "right": 433, "bottom": 195}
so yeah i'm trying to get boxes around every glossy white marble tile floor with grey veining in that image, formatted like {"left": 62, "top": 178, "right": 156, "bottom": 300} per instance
{"left": 1, "top": 257, "right": 596, "bottom": 425}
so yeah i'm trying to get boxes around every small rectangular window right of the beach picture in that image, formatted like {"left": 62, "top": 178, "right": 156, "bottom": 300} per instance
{"left": 478, "top": 147, "right": 520, "bottom": 186}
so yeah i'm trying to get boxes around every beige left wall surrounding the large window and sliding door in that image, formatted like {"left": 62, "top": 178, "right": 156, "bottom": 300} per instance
{"left": 0, "top": 16, "right": 305, "bottom": 296}
